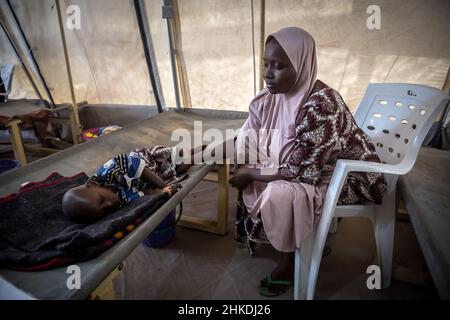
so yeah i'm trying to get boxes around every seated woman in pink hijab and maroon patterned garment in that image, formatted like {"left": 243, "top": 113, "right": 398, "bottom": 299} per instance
{"left": 230, "top": 27, "right": 386, "bottom": 296}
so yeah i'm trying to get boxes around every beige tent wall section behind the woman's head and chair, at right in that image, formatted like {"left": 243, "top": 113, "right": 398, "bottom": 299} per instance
{"left": 266, "top": 0, "right": 450, "bottom": 109}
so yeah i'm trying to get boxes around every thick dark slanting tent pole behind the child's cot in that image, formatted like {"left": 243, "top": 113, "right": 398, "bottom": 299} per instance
{"left": 134, "top": 0, "right": 165, "bottom": 113}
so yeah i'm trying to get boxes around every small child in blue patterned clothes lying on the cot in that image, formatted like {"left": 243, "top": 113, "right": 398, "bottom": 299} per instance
{"left": 62, "top": 145, "right": 200, "bottom": 223}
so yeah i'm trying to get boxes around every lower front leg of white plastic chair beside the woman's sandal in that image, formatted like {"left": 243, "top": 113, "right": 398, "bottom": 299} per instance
{"left": 294, "top": 232, "right": 315, "bottom": 300}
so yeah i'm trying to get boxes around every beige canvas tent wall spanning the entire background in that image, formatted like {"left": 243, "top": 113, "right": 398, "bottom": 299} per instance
{"left": 0, "top": 0, "right": 450, "bottom": 110}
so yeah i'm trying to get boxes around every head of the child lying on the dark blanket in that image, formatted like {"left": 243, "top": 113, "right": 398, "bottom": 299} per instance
{"left": 62, "top": 183, "right": 120, "bottom": 223}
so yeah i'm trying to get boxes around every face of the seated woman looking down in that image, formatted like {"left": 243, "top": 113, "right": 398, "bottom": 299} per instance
{"left": 264, "top": 38, "right": 297, "bottom": 94}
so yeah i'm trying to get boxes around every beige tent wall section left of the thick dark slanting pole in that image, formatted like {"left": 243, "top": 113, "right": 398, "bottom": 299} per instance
{"left": 3, "top": 0, "right": 155, "bottom": 104}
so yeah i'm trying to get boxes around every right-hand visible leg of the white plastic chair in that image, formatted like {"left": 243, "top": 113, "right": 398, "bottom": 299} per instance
{"left": 374, "top": 190, "right": 395, "bottom": 288}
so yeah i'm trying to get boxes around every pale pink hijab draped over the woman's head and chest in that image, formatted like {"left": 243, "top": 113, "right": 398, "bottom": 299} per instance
{"left": 237, "top": 27, "right": 317, "bottom": 165}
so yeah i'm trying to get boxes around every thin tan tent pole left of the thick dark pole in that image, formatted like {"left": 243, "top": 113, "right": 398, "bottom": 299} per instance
{"left": 55, "top": 0, "right": 81, "bottom": 144}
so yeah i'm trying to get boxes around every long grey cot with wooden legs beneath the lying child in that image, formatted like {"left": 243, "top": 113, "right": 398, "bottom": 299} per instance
{"left": 0, "top": 109, "right": 247, "bottom": 299}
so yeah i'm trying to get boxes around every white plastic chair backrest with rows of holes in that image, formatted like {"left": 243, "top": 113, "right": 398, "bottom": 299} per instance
{"left": 355, "top": 83, "right": 449, "bottom": 171}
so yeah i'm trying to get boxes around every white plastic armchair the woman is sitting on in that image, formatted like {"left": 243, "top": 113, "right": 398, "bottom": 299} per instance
{"left": 294, "top": 84, "right": 449, "bottom": 300}
